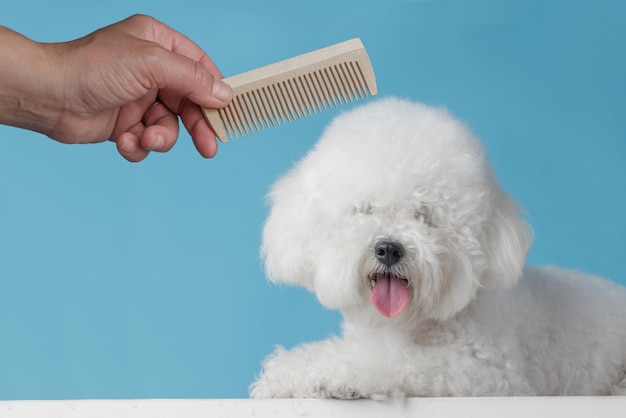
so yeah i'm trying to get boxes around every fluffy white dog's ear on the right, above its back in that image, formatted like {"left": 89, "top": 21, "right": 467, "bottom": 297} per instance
{"left": 481, "top": 185, "right": 532, "bottom": 287}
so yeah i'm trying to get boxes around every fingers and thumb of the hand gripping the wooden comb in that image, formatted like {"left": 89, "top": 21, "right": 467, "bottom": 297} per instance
{"left": 109, "top": 15, "right": 233, "bottom": 161}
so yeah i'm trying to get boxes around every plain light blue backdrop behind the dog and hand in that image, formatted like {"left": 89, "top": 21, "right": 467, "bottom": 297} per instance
{"left": 0, "top": 0, "right": 626, "bottom": 399}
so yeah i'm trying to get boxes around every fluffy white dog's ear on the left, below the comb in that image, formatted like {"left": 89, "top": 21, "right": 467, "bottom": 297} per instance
{"left": 261, "top": 170, "right": 314, "bottom": 290}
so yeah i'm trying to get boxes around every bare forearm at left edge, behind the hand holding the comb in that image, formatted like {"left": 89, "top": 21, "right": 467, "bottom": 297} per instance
{"left": 0, "top": 26, "right": 62, "bottom": 134}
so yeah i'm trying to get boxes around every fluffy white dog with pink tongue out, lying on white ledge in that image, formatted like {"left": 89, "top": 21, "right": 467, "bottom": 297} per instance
{"left": 251, "top": 99, "right": 626, "bottom": 399}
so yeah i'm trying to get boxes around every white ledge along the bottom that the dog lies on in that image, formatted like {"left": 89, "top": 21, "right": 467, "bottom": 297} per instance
{"left": 0, "top": 397, "right": 626, "bottom": 418}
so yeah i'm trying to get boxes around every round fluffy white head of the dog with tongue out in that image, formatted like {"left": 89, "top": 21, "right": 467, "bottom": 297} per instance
{"left": 262, "top": 99, "right": 531, "bottom": 319}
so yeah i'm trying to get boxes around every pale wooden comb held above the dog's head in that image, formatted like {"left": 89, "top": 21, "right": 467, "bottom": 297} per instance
{"left": 202, "top": 38, "right": 377, "bottom": 142}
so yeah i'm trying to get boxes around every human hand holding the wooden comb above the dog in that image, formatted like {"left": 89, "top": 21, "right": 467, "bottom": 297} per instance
{"left": 0, "top": 15, "right": 232, "bottom": 161}
